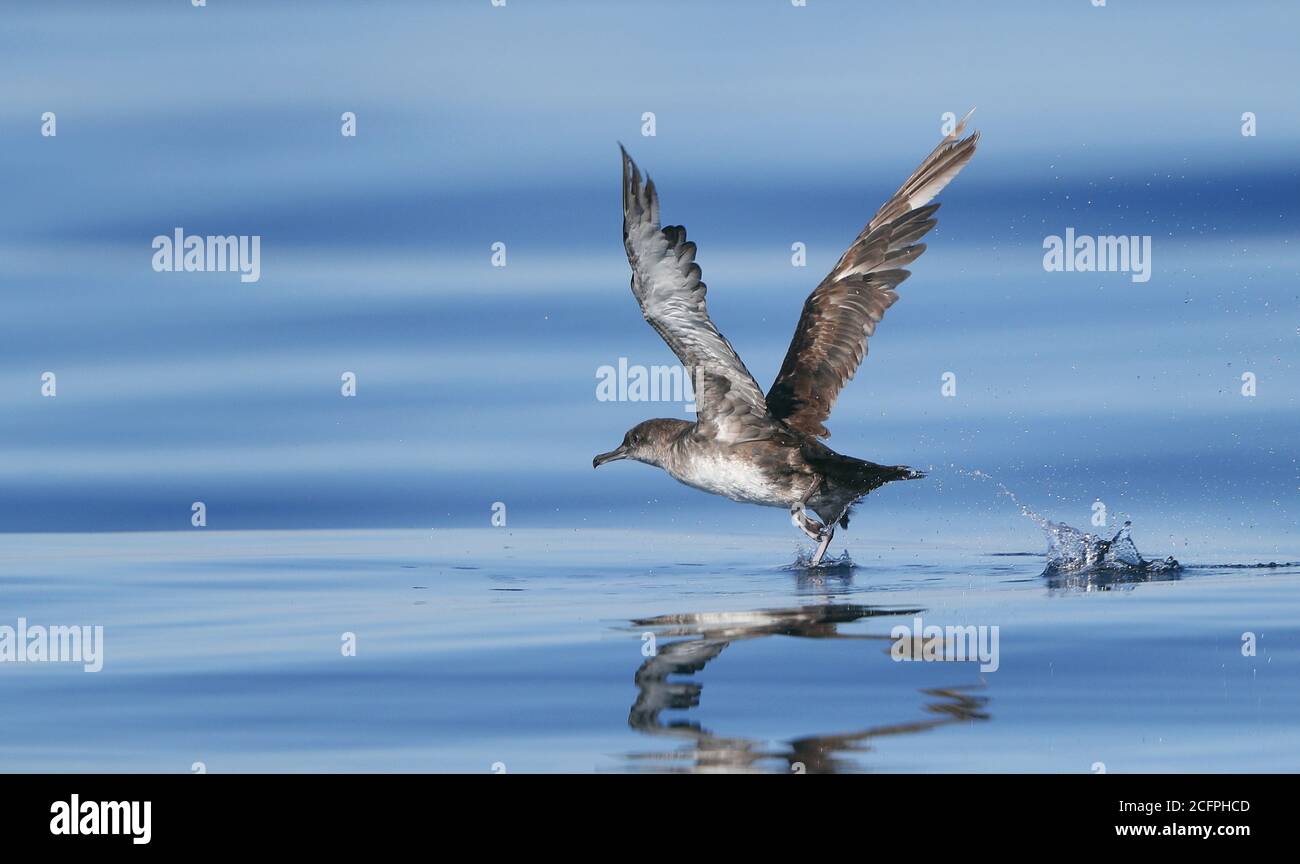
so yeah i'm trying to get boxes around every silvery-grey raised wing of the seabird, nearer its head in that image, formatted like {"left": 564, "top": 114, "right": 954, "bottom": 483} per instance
{"left": 619, "top": 147, "right": 775, "bottom": 442}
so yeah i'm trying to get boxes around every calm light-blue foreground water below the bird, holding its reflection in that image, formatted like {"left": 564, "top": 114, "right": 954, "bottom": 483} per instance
{"left": 0, "top": 522, "right": 1300, "bottom": 772}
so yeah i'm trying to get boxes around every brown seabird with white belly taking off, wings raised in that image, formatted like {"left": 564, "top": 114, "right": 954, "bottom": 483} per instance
{"left": 592, "top": 114, "right": 979, "bottom": 566}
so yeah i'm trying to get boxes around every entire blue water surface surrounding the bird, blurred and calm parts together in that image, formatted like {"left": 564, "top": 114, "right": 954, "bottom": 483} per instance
{"left": 0, "top": 0, "right": 1300, "bottom": 770}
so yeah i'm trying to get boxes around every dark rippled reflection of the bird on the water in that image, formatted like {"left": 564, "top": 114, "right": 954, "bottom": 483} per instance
{"left": 628, "top": 604, "right": 988, "bottom": 774}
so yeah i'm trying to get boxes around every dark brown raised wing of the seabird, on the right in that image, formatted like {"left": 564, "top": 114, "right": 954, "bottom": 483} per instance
{"left": 767, "top": 114, "right": 979, "bottom": 438}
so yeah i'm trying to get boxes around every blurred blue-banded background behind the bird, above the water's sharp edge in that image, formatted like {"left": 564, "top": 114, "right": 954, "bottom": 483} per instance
{"left": 0, "top": 0, "right": 1300, "bottom": 556}
